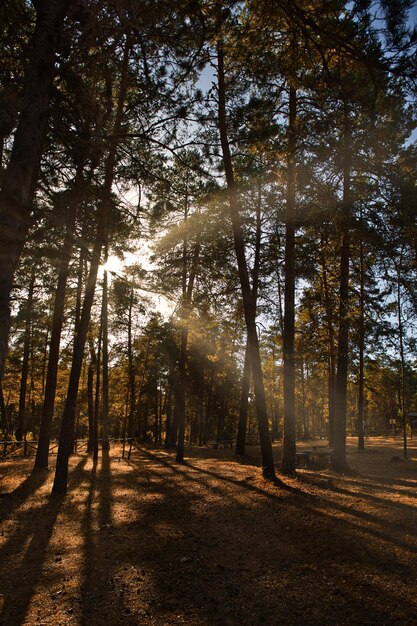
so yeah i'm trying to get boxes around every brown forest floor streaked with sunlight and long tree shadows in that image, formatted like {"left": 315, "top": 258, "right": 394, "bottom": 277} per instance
{"left": 0, "top": 439, "right": 417, "bottom": 626}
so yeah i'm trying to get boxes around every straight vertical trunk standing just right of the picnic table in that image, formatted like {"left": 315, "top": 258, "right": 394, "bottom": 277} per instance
{"left": 332, "top": 102, "right": 351, "bottom": 472}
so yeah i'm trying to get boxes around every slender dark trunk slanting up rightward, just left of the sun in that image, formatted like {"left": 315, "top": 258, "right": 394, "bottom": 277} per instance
{"left": 53, "top": 41, "right": 130, "bottom": 493}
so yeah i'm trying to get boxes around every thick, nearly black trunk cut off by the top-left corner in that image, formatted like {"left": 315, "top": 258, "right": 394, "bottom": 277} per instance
{"left": 0, "top": 0, "right": 70, "bottom": 380}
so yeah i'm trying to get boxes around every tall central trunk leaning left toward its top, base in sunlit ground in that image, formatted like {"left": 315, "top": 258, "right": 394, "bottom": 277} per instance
{"left": 217, "top": 41, "right": 275, "bottom": 478}
